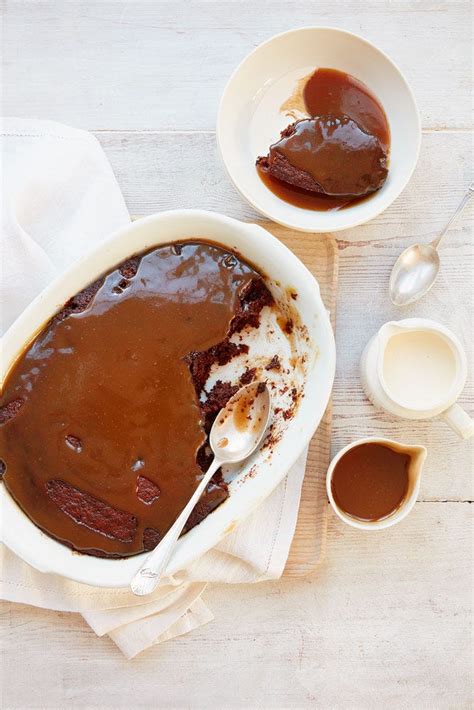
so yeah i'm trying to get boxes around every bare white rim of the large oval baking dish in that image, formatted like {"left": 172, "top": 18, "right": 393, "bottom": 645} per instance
{"left": 0, "top": 210, "right": 336, "bottom": 587}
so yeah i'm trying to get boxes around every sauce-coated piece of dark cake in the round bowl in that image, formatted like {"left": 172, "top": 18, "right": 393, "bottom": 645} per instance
{"left": 257, "top": 115, "right": 388, "bottom": 197}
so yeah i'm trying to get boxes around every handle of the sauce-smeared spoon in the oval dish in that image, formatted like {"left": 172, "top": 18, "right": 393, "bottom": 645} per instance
{"left": 130, "top": 457, "right": 222, "bottom": 596}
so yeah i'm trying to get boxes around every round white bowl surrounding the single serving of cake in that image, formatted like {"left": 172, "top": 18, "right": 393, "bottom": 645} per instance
{"left": 217, "top": 27, "right": 421, "bottom": 232}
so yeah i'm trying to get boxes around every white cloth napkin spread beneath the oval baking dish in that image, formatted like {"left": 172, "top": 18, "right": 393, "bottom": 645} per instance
{"left": 0, "top": 118, "right": 306, "bottom": 658}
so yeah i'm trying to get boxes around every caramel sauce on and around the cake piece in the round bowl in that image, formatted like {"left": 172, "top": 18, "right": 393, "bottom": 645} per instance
{"left": 257, "top": 68, "right": 390, "bottom": 211}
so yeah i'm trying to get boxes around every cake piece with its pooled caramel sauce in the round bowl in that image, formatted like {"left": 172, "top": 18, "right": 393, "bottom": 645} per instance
{"left": 256, "top": 68, "right": 390, "bottom": 211}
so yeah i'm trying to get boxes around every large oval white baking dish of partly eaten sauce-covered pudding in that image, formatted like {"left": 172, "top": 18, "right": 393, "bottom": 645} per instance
{"left": 0, "top": 210, "right": 335, "bottom": 586}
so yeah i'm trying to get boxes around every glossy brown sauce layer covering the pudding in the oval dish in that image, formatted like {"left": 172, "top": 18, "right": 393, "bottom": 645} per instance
{"left": 0, "top": 243, "right": 256, "bottom": 556}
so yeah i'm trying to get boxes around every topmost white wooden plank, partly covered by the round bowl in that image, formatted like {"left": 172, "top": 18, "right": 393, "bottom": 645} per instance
{"left": 2, "top": 0, "right": 472, "bottom": 130}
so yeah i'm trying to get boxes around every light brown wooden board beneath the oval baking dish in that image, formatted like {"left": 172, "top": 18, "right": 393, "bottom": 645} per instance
{"left": 261, "top": 222, "right": 338, "bottom": 577}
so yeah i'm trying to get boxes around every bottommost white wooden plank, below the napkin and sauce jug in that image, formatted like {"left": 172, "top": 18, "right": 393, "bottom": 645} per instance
{"left": 1, "top": 503, "right": 472, "bottom": 710}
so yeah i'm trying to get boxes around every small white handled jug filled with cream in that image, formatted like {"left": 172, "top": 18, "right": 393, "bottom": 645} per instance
{"left": 360, "top": 318, "right": 474, "bottom": 439}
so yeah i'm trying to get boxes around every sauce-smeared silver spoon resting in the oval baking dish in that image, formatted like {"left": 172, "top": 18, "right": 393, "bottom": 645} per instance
{"left": 130, "top": 382, "right": 270, "bottom": 596}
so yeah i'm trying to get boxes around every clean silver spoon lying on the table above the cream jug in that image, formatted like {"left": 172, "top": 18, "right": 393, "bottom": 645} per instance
{"left": 389, "top": 183, "right": 474, "bottom": 306}
